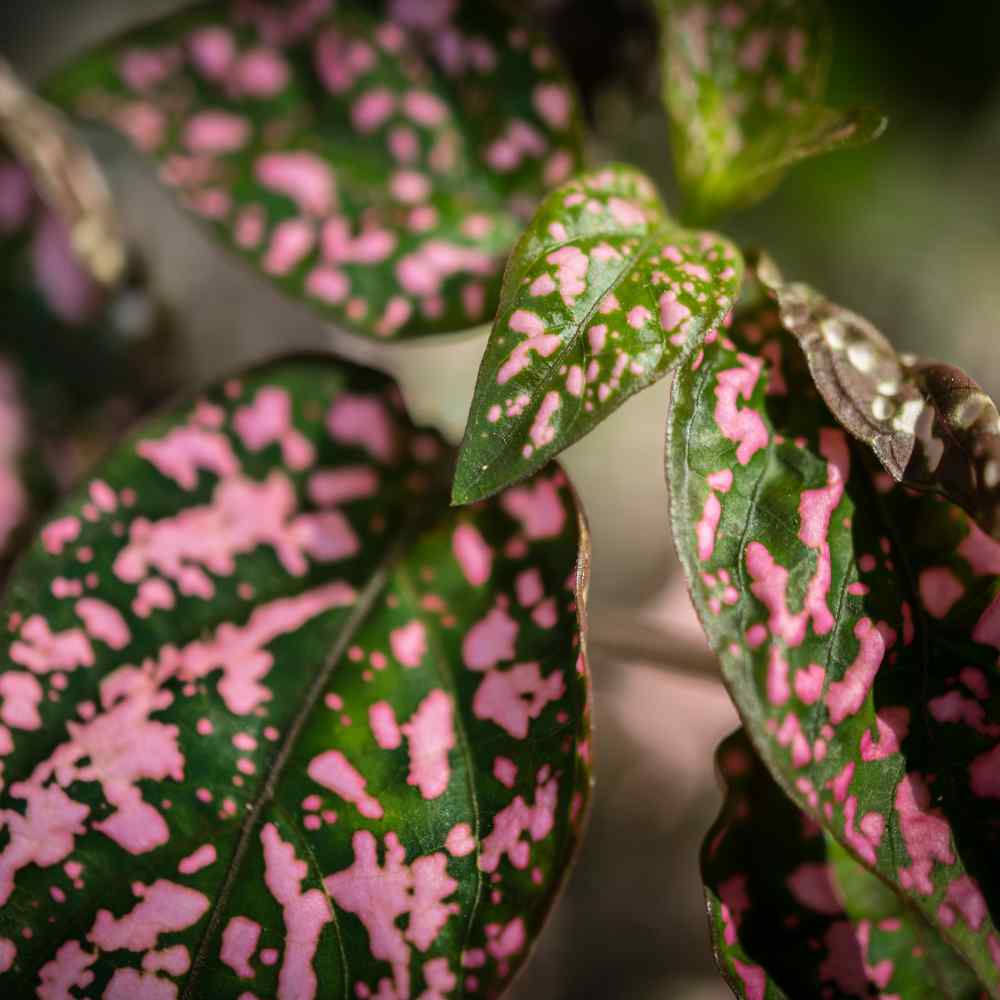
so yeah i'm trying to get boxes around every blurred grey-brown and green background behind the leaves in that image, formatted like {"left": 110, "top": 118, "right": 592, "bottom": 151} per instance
{"left": 0, "top": 0, "right": 1000, "bottom": 1000}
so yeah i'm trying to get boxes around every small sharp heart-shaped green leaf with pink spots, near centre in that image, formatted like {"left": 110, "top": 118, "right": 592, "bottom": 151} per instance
{"left": 453, "top": 166, "right": 743, "bottom": 503}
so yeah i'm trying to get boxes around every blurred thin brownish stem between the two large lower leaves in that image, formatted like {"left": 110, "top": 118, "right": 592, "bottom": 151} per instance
{"left": 588, "top": 611, "right": 720, "bottom": 682}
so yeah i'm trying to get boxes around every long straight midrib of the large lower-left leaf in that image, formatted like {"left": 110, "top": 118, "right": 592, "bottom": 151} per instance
{"left": 179, "top": 472, "right": 451, "bottom": 1000}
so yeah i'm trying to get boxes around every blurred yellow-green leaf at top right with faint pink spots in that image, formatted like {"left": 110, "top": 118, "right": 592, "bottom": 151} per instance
{"left": 658, "top": 0, "right": 886, "bottom": 221}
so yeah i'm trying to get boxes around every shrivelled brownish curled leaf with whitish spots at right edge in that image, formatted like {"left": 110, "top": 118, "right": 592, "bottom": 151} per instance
{"left": 755, "top": 258, "right": 1000, "bottom": 539}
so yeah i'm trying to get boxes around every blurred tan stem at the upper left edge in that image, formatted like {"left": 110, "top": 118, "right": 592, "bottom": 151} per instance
{"left": 0, "top": 59, "right": 126, "bottom": 285}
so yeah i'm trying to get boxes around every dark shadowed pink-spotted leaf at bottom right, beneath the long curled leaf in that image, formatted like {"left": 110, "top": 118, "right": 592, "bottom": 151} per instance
{"left": 701, "top": 731, "right": 982, "bottom": 1000}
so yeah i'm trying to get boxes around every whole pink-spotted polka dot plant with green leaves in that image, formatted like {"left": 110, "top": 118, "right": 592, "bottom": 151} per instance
{"left": 0, "top": 0, "right": 1000, "bottom": 1000}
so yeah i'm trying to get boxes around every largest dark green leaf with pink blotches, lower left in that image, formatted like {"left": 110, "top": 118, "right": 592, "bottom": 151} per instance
{"left": 0, "top": 358, "right": 590, "bottom": 1000}
